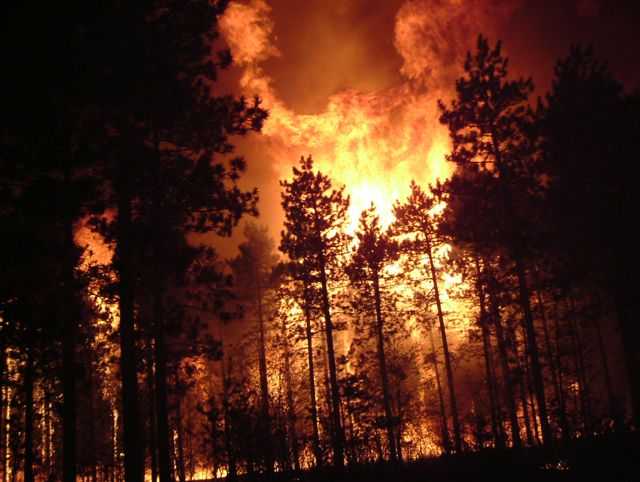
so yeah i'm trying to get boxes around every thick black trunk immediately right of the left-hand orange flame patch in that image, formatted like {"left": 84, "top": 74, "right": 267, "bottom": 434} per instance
{"left": 117, "top": 181, "right": 144, "bottom": 482}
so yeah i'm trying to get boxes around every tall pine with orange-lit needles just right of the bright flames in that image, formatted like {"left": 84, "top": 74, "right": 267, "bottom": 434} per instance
{"left": 439, "top": 36, "right": 552, "bottom": 444}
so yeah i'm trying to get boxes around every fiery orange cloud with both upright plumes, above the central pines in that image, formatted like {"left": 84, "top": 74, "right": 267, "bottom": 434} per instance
{"left": 220, "top": 0, "right": 502, "bottom": 234}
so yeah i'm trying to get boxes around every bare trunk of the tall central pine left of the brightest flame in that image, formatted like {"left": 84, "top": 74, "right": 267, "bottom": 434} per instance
{"left": 319, "top": 253, "right": 344, "bottom": 468}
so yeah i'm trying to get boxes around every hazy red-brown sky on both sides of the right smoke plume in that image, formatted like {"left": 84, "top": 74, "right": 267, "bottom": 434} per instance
{"left": 242, "top": 0, "right": 640, "bottom": 109}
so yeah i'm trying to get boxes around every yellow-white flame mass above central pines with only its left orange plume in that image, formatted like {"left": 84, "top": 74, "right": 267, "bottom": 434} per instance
{"left": 220, "top": 0, "right": 460, "bottom": 232}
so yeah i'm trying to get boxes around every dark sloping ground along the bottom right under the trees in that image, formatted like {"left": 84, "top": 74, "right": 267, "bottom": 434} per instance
{"left": 228, "top": 432, "right": 640, "bottom": 482}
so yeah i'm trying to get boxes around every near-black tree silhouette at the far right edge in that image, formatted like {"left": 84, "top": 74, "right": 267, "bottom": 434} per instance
{"left": 537, "top": 46, "right": 640, "bottom": 424}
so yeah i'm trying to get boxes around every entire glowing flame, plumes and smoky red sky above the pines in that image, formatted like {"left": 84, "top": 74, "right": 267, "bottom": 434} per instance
{"left": 216, "top": 0, "right": 633, "bottom": 249}
